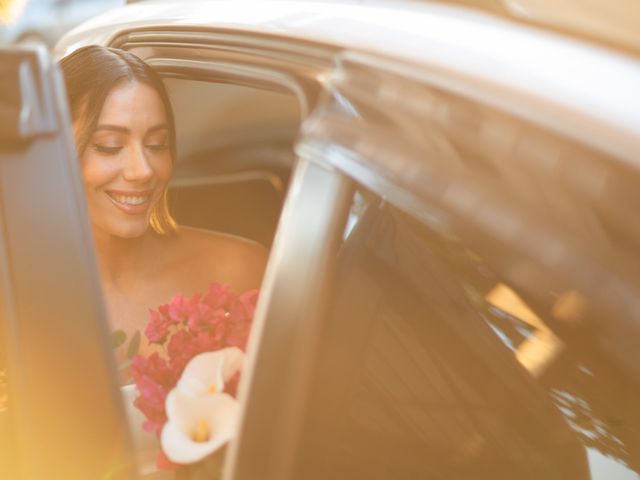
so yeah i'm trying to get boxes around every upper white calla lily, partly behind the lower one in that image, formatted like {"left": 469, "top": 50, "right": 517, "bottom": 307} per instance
{"left": 176, "top": 347, "right": 245, "bottom": 396}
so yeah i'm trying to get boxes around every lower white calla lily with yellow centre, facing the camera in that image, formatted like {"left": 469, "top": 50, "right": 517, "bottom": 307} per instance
{"left": 160, "top": 388, "right": 239, "bottom": 464}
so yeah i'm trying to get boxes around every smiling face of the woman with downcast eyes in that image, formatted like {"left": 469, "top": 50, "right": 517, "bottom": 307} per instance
{"left": 81, "top": 81, "right": 172, "bottom": 242}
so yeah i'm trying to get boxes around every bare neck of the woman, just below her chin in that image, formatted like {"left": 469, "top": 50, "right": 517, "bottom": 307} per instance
{"left": 93, "top": 228, "right": 160, "bottom": 289}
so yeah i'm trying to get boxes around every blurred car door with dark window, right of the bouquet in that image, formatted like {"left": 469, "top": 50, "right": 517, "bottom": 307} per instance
{"left": 233, "top": 45, "right": 640, "bottom": 480}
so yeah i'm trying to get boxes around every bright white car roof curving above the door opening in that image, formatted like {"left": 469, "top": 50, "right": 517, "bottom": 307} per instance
{"left": 56, "top": 0, "right": 640, "bottom": 163}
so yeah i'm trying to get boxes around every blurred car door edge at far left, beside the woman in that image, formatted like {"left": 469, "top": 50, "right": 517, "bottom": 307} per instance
{"left": 0, "top": 47, "right": 135, "bottom": 480}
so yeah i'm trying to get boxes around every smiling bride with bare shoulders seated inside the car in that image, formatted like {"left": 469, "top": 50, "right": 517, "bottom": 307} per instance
{"left": 60, "top": 46, "right": 267, "bottom": 473}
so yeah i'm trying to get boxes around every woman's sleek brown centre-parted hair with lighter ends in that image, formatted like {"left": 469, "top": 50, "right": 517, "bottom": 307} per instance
{"left": 60, "top": 45, "right": 177, "bottom": 234}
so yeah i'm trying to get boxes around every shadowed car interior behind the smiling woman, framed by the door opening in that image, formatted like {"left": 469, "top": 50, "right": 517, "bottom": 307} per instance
{"left": 165, "top": 78, "right": 300, "bottom": 247}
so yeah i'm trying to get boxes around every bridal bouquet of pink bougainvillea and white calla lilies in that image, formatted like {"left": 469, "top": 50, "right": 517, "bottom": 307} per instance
{"left": 131, "top": 283, "right": 258, "bottom": 474}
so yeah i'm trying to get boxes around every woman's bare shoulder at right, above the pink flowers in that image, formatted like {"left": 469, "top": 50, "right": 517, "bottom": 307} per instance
{"left": 168, "top": 227, "right": 268, "bottom": 293}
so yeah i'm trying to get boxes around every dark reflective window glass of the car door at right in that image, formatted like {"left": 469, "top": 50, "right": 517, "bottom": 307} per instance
{"left": 297, "top": 187, "right": 640, "bottom": 480}
